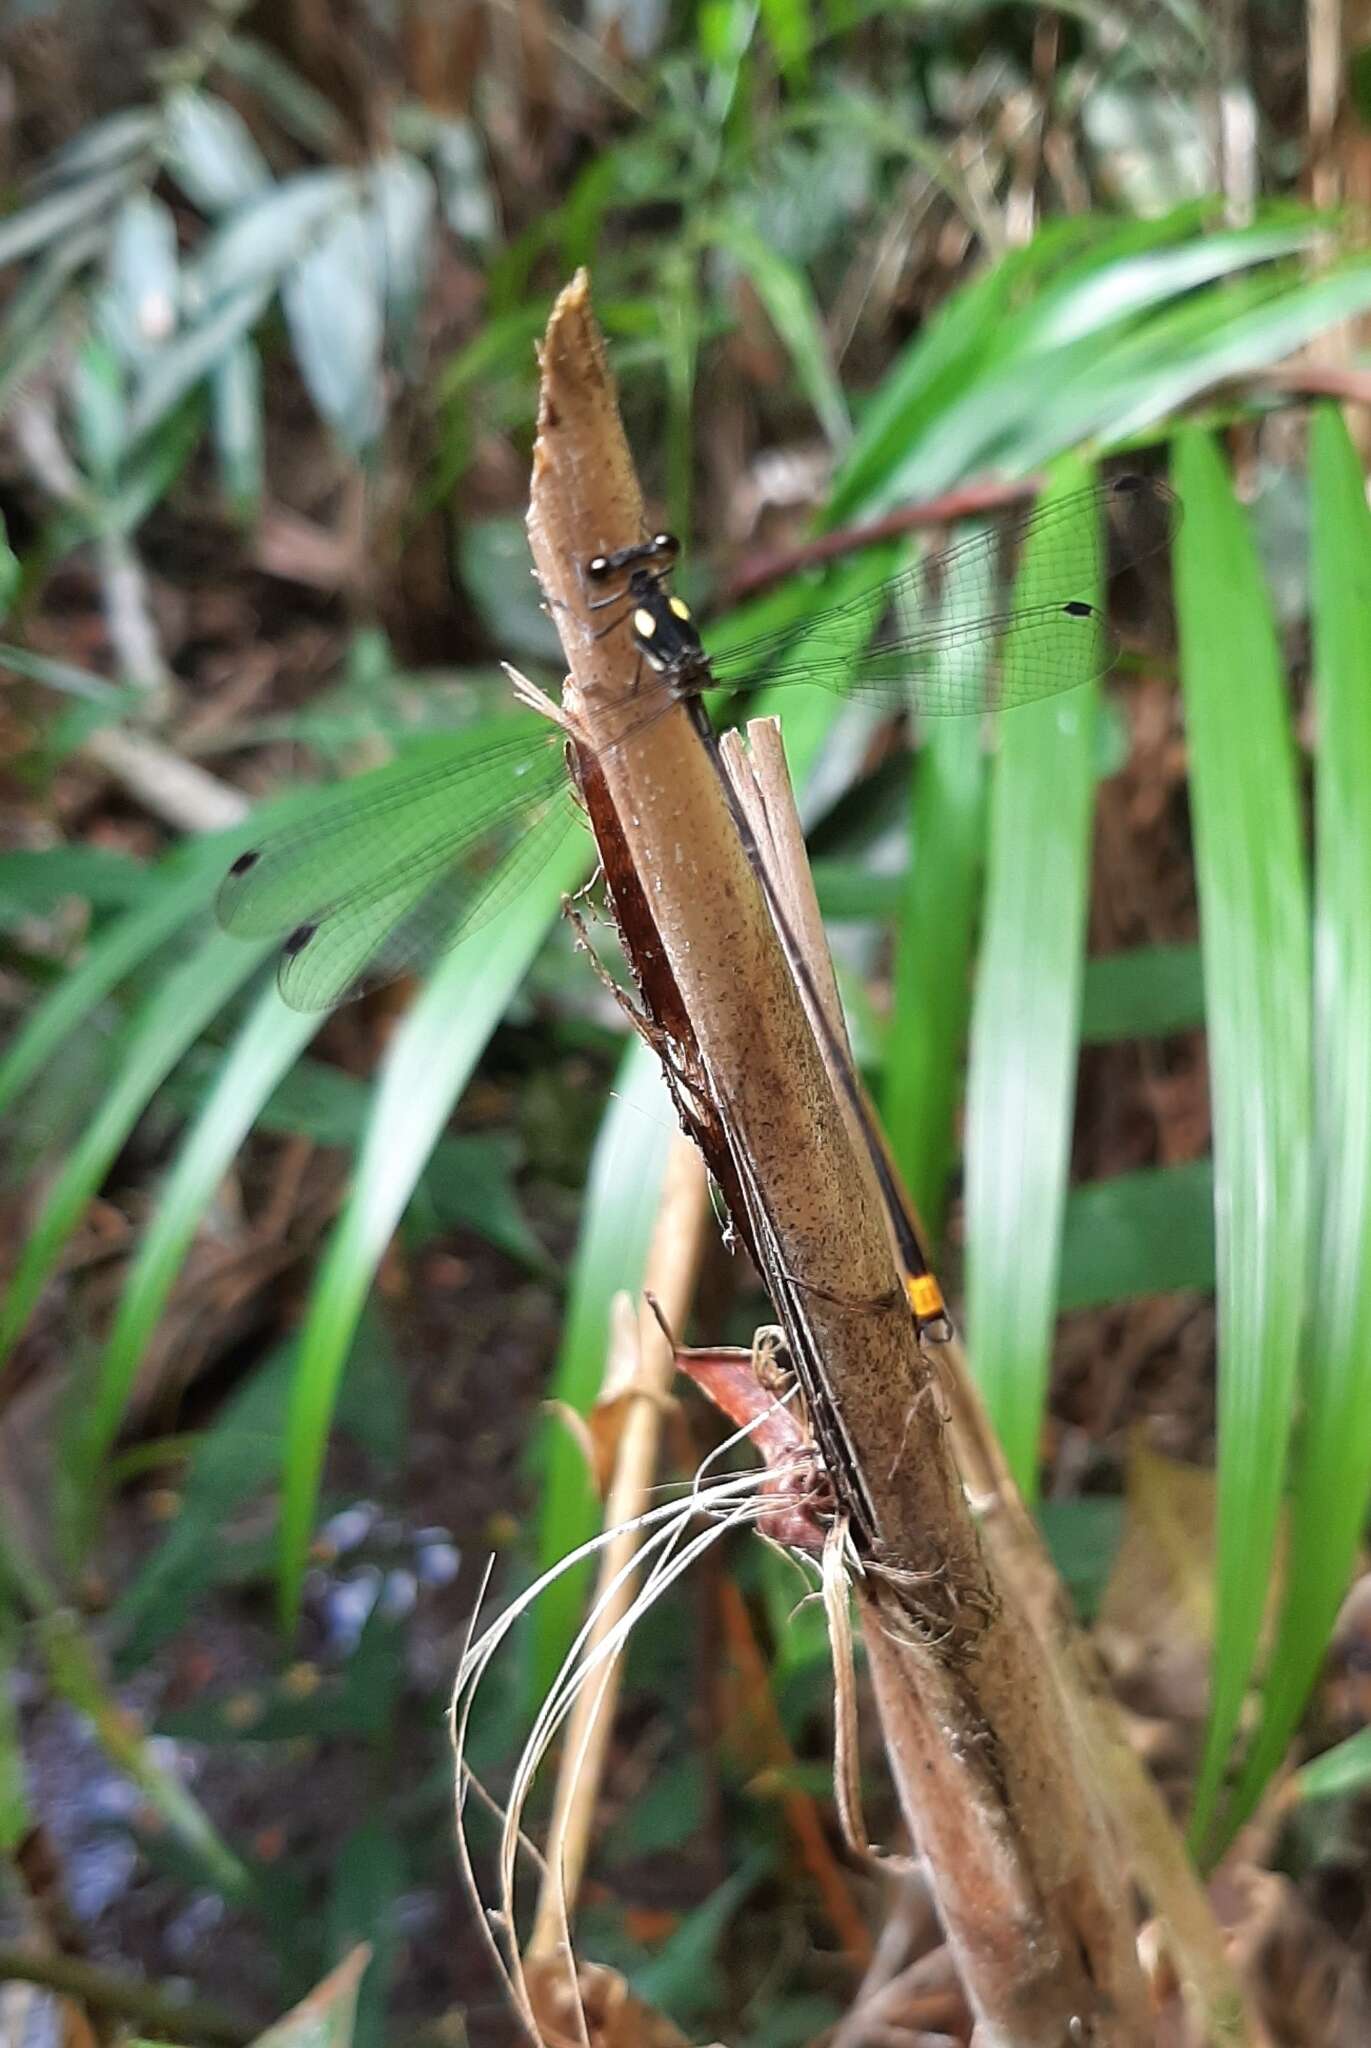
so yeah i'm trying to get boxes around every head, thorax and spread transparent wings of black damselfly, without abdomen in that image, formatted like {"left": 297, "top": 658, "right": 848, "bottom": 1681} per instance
{"left": 217, "top": 475, "right": 1178, "bottom": 1010}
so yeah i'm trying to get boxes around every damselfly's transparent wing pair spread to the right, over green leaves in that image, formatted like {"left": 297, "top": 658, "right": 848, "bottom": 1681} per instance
{"left": 713, "top": 477, "right": 1180, "bottom": 717}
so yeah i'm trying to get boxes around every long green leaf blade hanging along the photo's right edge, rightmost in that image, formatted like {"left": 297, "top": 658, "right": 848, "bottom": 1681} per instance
{"left": 1228, "top": 410, "right": 1371, "bottom": 1827}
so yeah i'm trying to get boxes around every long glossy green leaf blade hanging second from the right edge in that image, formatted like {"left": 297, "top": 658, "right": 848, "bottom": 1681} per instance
{"left": 1176, "top": 432, "right": 1312, "bottom": 1849}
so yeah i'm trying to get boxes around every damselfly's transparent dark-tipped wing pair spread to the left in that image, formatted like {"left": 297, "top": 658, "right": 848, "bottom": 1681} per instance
{"left": 215, "top": 719, "right": 574, "bottom": 1010}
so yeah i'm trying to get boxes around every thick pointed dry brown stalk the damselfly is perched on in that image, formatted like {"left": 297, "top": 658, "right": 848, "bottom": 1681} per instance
{"left": 529, "top": 276, "right": 1152, "bottom": 2048}
